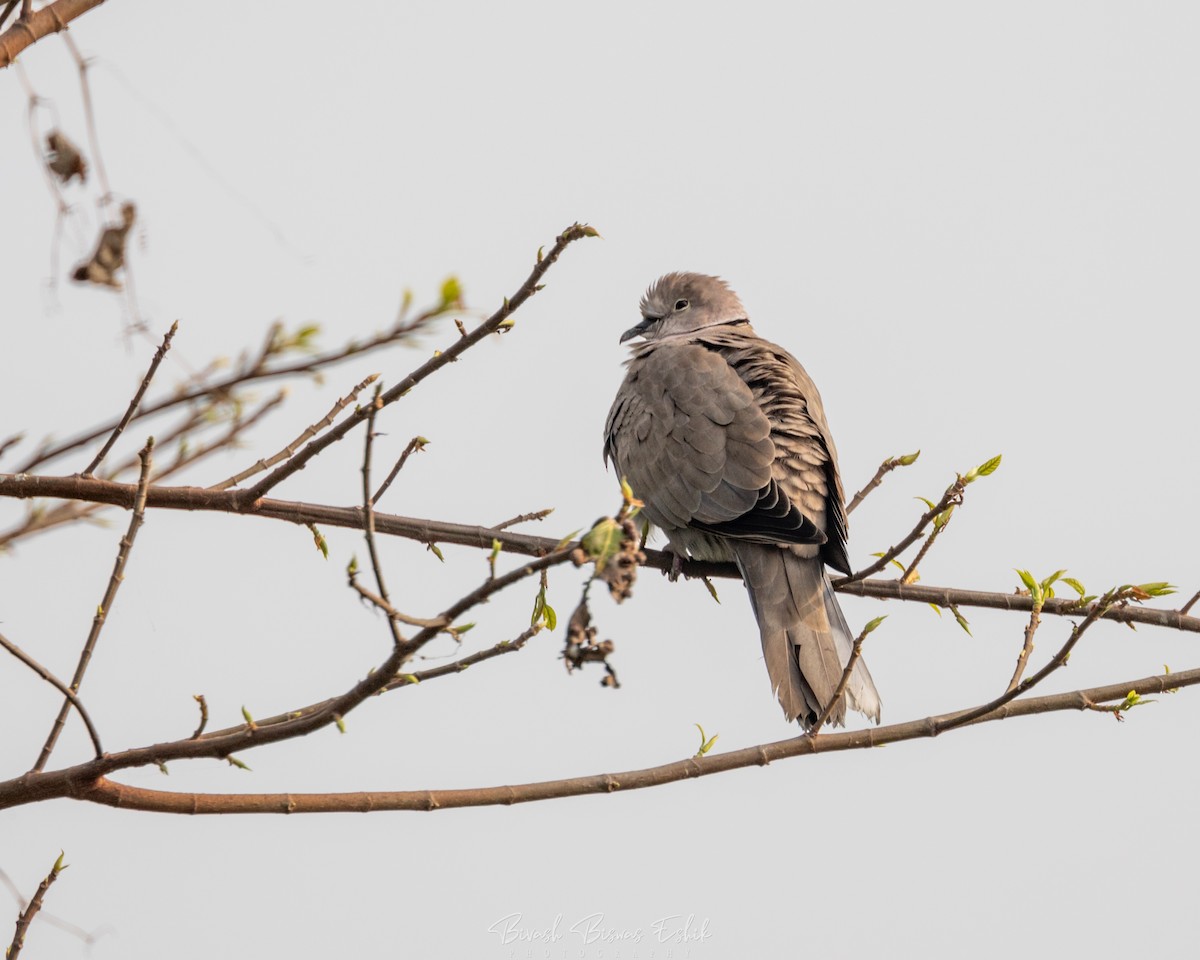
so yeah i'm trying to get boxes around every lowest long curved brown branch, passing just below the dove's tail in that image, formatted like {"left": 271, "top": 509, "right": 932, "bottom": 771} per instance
{"left": 63, "top": 670, "right": 1200, "bottom": 814}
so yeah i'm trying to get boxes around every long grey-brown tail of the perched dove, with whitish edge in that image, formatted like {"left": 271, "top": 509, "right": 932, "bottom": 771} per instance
{"left": 733, "top": 542, "right": 880, "bottom": 727}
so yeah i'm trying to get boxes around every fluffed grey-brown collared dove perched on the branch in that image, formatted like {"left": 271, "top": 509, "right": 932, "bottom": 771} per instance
{"left": 605, "top": 274, "right": 880, "bottom": 728}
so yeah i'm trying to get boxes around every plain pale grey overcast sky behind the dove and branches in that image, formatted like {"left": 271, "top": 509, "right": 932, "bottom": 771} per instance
{"left": 0, "top": 0, "right": 1200, "bottom": 960}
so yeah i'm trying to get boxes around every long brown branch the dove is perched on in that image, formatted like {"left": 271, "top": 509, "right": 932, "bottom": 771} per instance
{"left": 0, "top": 474, "right": 1200, "bottom": 634}
